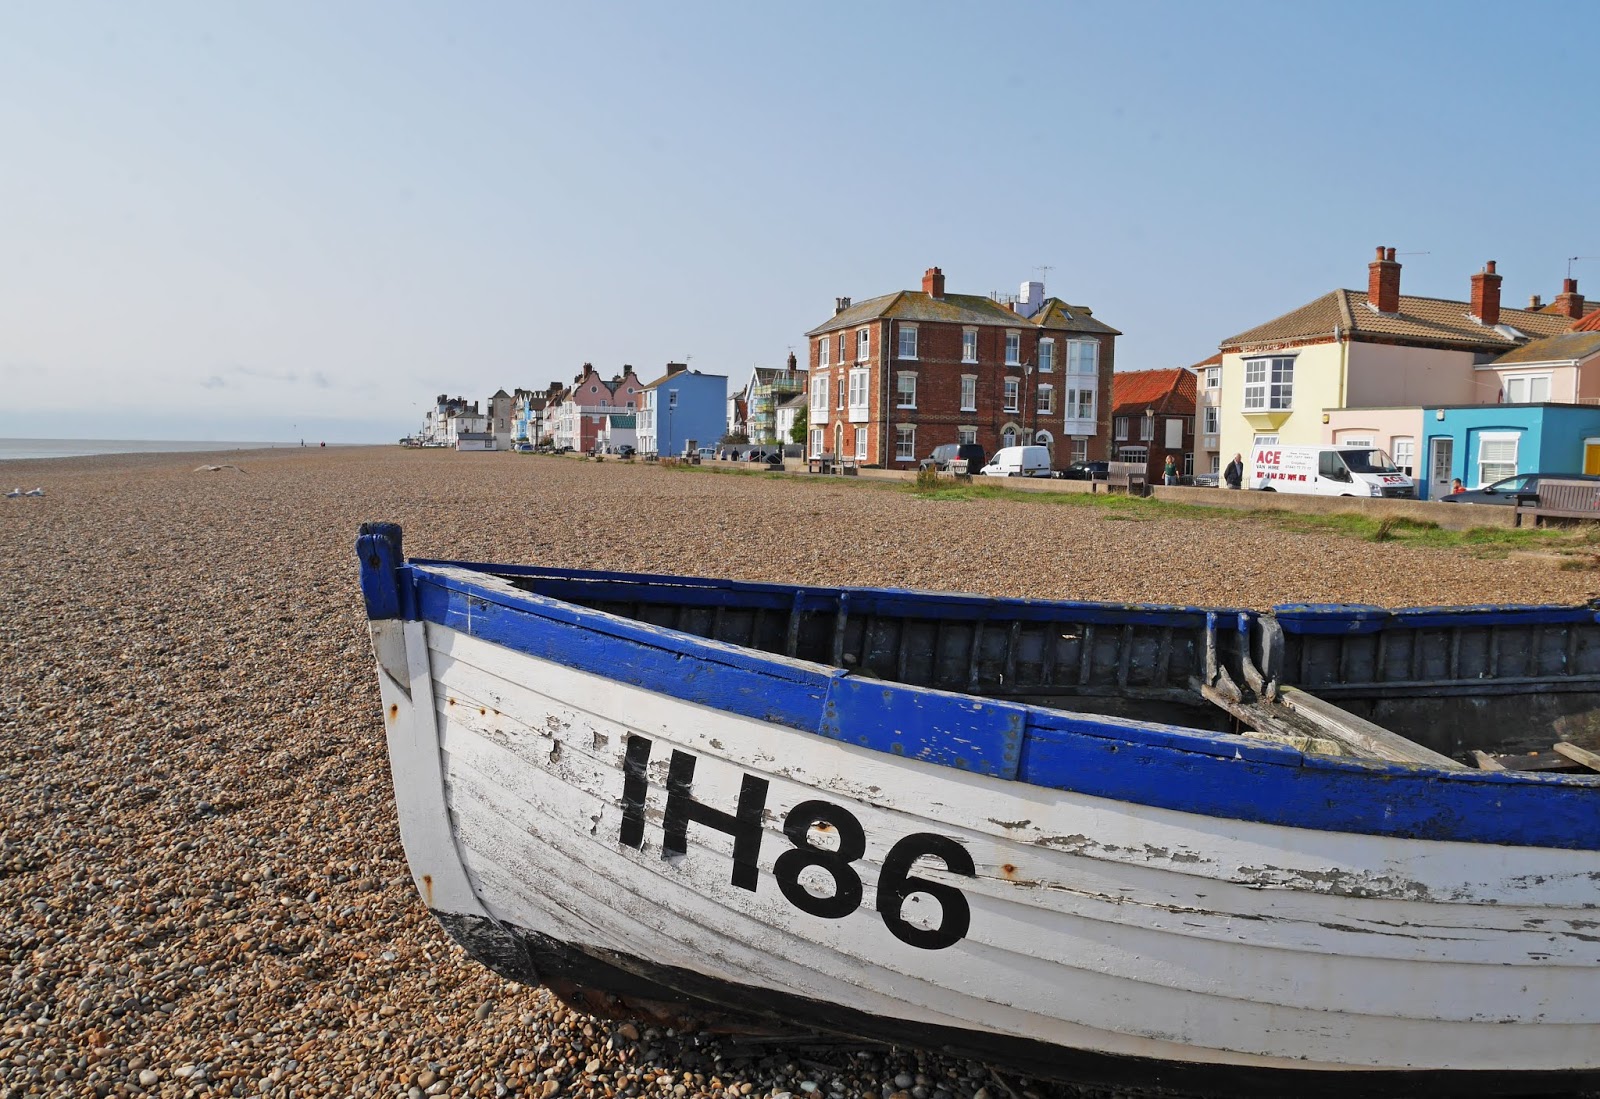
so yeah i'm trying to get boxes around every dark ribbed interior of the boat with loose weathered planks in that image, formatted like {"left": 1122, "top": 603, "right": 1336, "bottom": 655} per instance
{"left": 501, "top": 569, "right": 1600, "bottom": 774}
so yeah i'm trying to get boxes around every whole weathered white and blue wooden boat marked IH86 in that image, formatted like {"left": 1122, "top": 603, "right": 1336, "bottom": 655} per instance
{"left": 357, "top": 523, "right": 1600, "bottom": 1096}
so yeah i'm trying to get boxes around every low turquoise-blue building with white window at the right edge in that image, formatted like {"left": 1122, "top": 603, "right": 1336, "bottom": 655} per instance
{"left": 1416, "top": 405, "right": 1600, "bottom": 498}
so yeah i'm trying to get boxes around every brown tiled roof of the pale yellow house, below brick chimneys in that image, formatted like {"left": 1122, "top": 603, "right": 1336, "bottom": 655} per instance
{"left": 1221, "top": 290, "right": 1568, "bottom": 350}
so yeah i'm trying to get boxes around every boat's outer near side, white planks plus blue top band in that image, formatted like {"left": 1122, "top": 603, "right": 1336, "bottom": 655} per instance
{"left": 363, "top": 527, "right": 1600, "bottom": 1094}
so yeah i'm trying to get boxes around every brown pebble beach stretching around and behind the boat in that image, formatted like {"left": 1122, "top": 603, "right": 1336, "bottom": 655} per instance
{"left": 0, "top": 446, "right": 1600, "bottom": 1099}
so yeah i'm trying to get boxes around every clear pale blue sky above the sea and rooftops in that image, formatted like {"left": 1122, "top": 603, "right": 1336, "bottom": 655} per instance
{"left": 0, "top": 0, "right": 1600, "bottom": 442}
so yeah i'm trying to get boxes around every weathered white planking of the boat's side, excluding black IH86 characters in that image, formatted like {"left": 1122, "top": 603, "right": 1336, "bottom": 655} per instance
{"left": 371, "top": 619, "right": 1600, "bottom": 1073}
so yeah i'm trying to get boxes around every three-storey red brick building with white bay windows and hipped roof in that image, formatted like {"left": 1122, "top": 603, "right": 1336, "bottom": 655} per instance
{"left": 806, "top": 267, "right": 1122, "bottom": 469}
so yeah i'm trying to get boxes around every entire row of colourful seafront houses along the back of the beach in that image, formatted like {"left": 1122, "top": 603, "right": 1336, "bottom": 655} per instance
{"left": 409, "top": 248, "right": 1600, "bottom": 498}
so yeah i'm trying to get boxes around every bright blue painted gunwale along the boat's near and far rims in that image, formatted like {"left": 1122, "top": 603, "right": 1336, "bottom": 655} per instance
{"left": 363, "top": 555, "right": 1600, "bottom": 851}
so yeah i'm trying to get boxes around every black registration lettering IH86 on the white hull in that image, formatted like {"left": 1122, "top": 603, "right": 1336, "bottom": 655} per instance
{"left": 618, "top": 736, "right": 976, "bottom": 950}
